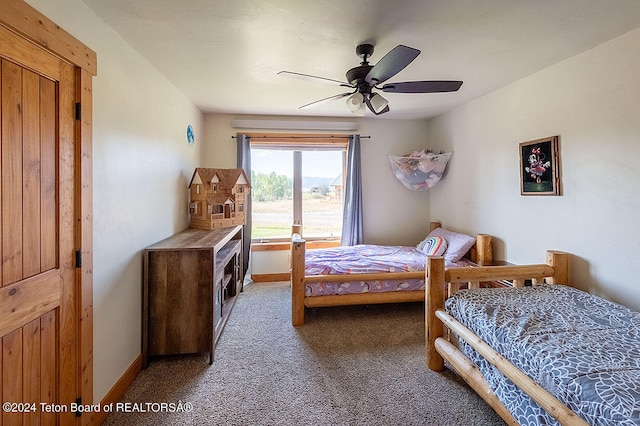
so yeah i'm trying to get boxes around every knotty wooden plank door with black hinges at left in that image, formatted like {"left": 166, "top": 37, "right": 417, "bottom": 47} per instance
{"left": 0, "top": 27, "right": 80, "bottom": 425}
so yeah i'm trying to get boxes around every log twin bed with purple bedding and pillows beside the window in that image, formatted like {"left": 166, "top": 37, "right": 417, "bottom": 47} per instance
{"left": 291, "top": 222, "right": 493, "bottom": 326}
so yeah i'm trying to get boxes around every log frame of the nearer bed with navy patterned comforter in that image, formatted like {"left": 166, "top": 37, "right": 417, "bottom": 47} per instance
{"left": 425, "top": 251, "right": 587, "bottom": 425}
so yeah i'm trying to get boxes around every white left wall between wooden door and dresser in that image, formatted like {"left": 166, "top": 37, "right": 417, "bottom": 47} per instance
{"left": 28, "top": 0, "right": 202, "bottom": 402}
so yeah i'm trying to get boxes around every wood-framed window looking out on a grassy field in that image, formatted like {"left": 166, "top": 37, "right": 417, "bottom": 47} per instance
{"left": 251, "top": 137, "right": 346, "bottom": 241}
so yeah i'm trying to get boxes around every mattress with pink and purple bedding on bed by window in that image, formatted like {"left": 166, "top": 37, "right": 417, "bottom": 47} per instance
{"left": 305, "top": 244, "right": 471, "bottom": 297}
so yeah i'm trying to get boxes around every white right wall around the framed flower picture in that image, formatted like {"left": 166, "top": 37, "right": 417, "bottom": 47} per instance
{"left": 429, "top": 30, "right": 640, "bottom": 309}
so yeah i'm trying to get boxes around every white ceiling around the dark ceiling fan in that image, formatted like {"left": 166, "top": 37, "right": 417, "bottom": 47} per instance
{"left": 84, "top": 0, "right": 640, "bottom": 119}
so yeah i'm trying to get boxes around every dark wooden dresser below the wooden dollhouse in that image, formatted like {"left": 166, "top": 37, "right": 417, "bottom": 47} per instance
{"left": 142, "top": 226, "right": 244, "bottom": 368}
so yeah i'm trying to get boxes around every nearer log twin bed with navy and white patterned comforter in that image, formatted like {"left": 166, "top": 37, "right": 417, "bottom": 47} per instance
{"left": 425, "top": 251, "right": 640, "bottom": 425}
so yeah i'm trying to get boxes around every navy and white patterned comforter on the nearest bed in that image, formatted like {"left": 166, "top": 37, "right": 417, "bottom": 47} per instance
{"left": 446, "top": 285, "right": 640, "bottom": 426}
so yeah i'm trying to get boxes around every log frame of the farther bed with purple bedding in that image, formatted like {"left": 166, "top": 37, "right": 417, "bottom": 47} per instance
{"left": 291, "top": 222, "right": 493, "bottom": 326}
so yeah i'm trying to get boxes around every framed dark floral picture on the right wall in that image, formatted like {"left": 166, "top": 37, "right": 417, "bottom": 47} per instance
{"left": 520, "top": 136, "right": 561, "bottom": 195}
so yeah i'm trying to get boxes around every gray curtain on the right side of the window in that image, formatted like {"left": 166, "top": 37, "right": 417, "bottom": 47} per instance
{"left": 341, "top": 135, "right": 364, "bottom": 246}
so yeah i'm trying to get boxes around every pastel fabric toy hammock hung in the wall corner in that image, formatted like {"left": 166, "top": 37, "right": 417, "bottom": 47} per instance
{"left": 389, "top": 150, "right": 452, "bottom": 191}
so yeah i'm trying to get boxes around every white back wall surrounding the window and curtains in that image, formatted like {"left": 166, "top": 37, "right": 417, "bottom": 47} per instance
{"left": 201, "top": 114, "right": 429, "bottom": 250}
